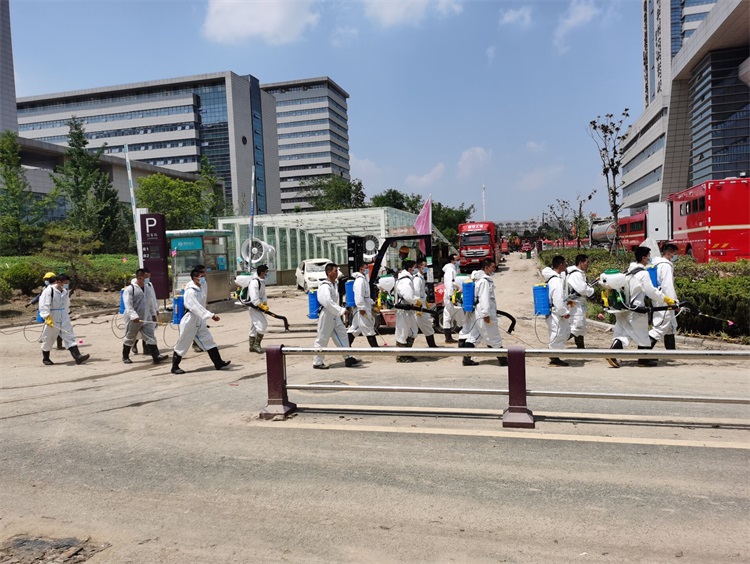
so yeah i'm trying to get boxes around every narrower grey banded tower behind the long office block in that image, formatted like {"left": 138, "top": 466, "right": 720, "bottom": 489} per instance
{"left": 261, "top": 77, "right": 350, "bottom": 212}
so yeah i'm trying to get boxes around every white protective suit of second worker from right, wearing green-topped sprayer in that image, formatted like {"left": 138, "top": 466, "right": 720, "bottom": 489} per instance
{"left": 612, "top": 262, "right": 664, "bottom": 348}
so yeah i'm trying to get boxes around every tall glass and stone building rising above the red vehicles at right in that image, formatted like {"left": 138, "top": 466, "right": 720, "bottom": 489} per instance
{"left": 622, "top": 0, "right": 750, "bottom": 211}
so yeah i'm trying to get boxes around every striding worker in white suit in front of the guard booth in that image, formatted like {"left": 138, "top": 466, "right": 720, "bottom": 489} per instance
{"left": 172, "top": 268, "right": 231, "bottom": 374}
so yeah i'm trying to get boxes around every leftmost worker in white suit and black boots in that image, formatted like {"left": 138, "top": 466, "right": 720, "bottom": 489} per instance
{"left": 39, "top": 274, "right": 90, "bottom": 366}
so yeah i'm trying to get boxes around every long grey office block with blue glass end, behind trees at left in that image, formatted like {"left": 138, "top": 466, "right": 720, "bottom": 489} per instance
{"left": 17, "top": 72, "right": 281, "bottom": 214}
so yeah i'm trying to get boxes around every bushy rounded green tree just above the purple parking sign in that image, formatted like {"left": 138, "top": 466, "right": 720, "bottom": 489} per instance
{"left": 135, "top": 174, "right": 214, "bottom": 230}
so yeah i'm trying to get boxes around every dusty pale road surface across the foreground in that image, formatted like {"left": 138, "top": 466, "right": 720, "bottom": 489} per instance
{"left": 0, "top": 256, "right": 750, "bottom": 563}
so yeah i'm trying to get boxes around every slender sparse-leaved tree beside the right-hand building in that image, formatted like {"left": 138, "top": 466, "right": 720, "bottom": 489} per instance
{"left": 589, "top": 108, "right": 630, "bottom": 253}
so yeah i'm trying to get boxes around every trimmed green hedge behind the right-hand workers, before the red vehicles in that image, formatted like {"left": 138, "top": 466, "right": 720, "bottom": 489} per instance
{"left": 539, "top": 249, "right": 750, "bottom": 337}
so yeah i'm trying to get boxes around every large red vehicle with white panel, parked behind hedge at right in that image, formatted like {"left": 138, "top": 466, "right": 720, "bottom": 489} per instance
{"left": 618, "top": 178, "right": 750, "bottom": 262}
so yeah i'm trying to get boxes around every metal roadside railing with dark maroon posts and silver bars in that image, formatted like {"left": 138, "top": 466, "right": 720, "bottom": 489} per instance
{"left": 260, "top": 345, "right": 750, "bottom": 429}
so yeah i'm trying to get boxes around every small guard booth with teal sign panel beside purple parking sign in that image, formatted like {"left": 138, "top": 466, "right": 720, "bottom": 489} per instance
{"left": 167, "top": 229, "right": 234, "bottom": 302}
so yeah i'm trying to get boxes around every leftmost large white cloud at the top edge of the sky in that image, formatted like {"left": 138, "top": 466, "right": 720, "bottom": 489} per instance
{"left": 203, "top": 0, "right": 320, "bottom": 45}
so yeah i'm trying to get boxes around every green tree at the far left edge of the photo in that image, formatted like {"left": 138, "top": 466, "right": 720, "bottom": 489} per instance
{"left": 0, "top": 130, "right": 54, "bottom": 255}
